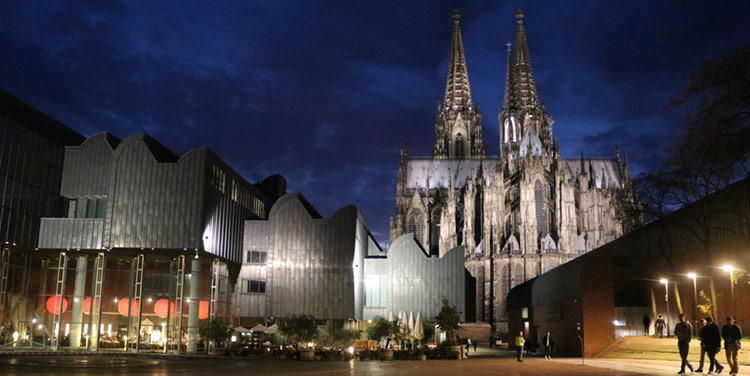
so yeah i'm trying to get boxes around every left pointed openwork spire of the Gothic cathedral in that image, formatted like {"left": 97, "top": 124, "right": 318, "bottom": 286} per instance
{"left": 445, "top": 9, "right": 472, "bottom": 106}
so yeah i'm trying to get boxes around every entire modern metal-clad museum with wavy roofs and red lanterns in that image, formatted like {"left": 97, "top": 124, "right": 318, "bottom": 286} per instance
{"left": 0, "top": 91, "right": 466, "bottom": 352}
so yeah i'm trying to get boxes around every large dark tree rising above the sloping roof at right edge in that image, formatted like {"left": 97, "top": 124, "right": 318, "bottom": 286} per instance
{"left": 637, "top": 44, "right": 750, "bottom": 257}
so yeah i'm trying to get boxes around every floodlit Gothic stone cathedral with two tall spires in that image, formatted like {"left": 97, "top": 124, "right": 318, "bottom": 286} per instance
{"left": 390, "top": 9, "right": 634, "bottom": 331}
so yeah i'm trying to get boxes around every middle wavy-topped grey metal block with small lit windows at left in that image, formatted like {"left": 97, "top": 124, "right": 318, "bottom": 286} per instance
{"left": 235, "top": 193, "right": 371, "bottom": 320}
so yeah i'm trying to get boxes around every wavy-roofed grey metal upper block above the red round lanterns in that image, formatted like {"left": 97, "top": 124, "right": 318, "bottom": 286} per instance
{"left": 38, "top": 133, "right": 271, "bottom": 263}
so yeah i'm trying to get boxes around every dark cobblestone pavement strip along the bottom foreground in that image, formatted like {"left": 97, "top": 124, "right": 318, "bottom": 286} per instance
{"left": 0, "top": 356, "right": 648, "bottom": 376}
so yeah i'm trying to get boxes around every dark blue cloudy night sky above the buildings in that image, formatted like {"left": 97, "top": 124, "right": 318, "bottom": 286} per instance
{"left": 0, "top": 0, "right": 750, "bottom": 241}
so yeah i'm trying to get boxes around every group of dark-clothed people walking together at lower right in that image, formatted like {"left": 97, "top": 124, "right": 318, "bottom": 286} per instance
{"left": 674, "top": 313, "right": 742, "bottom": 375}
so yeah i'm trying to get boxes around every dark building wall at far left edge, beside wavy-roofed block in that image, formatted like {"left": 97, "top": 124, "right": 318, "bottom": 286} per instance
{"left": 0, "top": 90, "right": 83, "bottom": 249}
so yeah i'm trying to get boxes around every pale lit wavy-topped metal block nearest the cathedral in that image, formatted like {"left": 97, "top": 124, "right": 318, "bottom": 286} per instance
{"left": 364, "top": 233, "right": 467, "bottom": 321}
